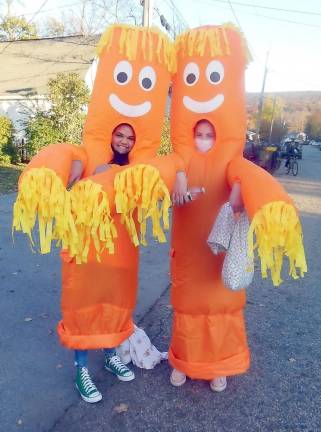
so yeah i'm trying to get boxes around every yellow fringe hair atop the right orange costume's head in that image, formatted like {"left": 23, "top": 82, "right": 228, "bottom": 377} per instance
{"left": 175, "top": 23, "right": 252, "bottom": 64}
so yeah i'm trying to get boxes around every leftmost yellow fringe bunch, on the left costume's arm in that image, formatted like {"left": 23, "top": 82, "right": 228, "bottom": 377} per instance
{"left": 12, "top": 168, "right": 77, "bottom": 254}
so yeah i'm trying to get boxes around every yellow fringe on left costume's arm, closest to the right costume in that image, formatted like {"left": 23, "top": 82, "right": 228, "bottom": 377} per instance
{"left": 114, "top": 164, "right": 171, "bottom": 246}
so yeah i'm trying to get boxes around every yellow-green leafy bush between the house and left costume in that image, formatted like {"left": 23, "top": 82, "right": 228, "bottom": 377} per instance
{"left": 25, "top": 73, "right": 89, "bottom": 156}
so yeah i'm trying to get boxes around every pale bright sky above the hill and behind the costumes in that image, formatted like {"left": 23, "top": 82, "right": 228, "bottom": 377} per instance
{"left": 3, "top": 0, "right": 321, "bottom": 91}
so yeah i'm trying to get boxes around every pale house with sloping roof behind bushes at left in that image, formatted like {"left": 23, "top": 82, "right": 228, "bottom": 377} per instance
{"left": 0, "top": 35, "right": 100, "bottom": 142}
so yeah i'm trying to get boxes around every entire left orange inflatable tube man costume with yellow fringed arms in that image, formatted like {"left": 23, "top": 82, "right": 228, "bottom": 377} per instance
{"left": 13, "top": 25, "right": 182, "bottom": 349}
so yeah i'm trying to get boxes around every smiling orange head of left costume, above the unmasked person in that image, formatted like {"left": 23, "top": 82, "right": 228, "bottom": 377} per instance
{"left": 83, "top": 24, "right": 175, "bottom": 172}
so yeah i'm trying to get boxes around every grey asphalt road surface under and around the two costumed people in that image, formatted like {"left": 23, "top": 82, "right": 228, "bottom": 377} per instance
{"left": 0, "top": 147, "right": 321, "bottom": 432}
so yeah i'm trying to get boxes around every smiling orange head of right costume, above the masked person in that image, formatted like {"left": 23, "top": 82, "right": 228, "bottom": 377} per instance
{"left": 171, "top": 26, "right": 246, "bottom": 159}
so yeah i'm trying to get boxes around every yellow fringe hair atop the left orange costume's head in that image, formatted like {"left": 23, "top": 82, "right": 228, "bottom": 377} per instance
{"left": 96, "top": 24, "right": 176, "bottom": 73}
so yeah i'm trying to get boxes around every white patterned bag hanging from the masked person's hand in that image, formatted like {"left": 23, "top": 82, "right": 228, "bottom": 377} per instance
{"left": 208, "top": 203, "right": 254, "bottom": 291}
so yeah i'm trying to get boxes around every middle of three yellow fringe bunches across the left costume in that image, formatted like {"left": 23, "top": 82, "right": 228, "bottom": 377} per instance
{"left": 69, "top": 180, "right": 117, "bottom": 264}
